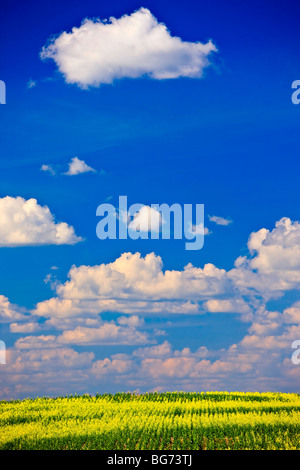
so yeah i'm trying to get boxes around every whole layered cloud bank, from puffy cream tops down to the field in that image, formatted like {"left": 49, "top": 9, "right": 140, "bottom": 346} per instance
{"left": 4, "top": 218, "right": 300, "bottom": 398}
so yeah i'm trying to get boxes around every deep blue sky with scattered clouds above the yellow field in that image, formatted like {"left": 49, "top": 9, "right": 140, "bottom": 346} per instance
{"left": 0, "top": 0, "right": 300, "bottom": 398}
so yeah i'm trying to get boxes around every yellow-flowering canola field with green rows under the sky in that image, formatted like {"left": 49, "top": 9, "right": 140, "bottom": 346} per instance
{"left": 0, "top": 392, "right": 300, "bottom": 450}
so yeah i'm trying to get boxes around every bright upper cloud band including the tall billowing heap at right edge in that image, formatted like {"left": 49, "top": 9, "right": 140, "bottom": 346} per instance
{"left": 34, "top": 219, "right": 300, "bottom": 321}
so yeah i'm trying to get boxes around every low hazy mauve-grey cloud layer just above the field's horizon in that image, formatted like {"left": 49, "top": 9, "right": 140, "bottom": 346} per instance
{"left": 5, "top": 311, "right": 300, "bottom": 398}
